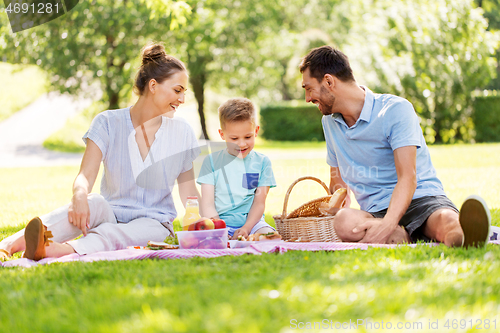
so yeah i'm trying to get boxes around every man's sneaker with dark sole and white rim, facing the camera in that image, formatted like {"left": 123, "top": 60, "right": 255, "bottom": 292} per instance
{"left": 460, "top": 195, "right": 491, "bottom": 247}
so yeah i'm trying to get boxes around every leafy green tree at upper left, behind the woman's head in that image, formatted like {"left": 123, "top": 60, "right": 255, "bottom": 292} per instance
{"left": 0, "top": 0, "right": 190, "bottom": 109}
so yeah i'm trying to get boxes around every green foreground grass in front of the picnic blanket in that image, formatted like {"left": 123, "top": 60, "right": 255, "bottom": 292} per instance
{"left": 0, "top": 245, "right": 500, "bottom": 333}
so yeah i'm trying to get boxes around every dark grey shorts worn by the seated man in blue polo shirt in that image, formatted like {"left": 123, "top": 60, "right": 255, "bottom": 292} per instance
{"left": 370, "top": 195, "right": 458, "bottom": 242}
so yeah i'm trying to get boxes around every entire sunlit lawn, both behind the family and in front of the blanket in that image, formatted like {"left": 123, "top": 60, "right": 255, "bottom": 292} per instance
{"left": 0, "top": 143, "right": 500, "bottom": 332}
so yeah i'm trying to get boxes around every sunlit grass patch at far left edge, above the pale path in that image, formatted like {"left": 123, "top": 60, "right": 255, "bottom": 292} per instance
{"left": 0, "top": 62, "right": 47, "bottom": 121}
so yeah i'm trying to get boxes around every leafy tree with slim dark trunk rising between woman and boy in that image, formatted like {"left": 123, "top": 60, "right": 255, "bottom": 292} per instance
{"left": 169, "top": 0, "right": 346, "bottom": 138}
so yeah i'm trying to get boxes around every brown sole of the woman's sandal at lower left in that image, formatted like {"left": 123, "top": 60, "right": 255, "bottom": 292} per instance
{"left": 23, "top": 217, "right": 53, "bottom": 260}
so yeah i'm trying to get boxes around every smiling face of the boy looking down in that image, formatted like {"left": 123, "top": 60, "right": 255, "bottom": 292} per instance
{"left": 219, "top": 121, "right": 259, "bottom": 158}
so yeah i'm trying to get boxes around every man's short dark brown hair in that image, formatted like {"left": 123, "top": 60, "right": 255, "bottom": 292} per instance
{"left": 299, "top": 45, "right": 354, "bottom": 82}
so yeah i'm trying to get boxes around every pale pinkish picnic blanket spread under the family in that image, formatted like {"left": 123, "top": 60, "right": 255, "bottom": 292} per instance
{"left": 0, "top": 240, "right": 500, "bottom": 267}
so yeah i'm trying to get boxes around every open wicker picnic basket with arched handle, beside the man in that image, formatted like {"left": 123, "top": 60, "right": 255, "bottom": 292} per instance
{"left": 274, "top": 176, "right": 341, "bottom": 242}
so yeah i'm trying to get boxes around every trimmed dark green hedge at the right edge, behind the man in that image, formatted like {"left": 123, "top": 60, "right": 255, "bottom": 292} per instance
{"left": 472, "top": 91, "right": 500, "bottom": 142}
